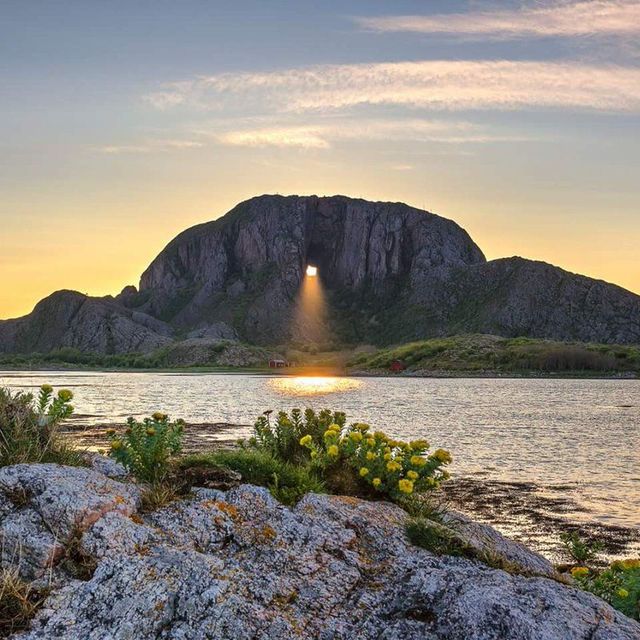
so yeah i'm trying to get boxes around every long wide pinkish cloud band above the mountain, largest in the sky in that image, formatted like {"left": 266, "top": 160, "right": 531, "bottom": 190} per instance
{"left": 146, "top": 60, "right": 640, "bottom": 113}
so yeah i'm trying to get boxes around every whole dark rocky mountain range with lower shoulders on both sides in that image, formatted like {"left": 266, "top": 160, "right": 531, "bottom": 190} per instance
{"left": 0, "top": 195, "right": 640, "bottom": 353}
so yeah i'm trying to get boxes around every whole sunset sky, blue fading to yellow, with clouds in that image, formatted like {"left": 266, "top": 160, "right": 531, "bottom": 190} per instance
{"left": 0, "top": 0, "right": 640, "bottom": 318}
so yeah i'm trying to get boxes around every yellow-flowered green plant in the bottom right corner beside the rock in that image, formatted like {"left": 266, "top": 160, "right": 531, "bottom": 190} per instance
{"left": 571, "top": 559, "right": 640, "bottom": 620}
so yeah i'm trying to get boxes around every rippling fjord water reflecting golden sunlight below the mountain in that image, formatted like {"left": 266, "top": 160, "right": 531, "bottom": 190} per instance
{"left": 0, "top": 371, "right": 640, "bottom": 527}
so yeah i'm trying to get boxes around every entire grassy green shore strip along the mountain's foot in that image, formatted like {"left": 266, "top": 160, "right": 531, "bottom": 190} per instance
{"left": 0, "top": 334, "right": 640, "bottom": 378}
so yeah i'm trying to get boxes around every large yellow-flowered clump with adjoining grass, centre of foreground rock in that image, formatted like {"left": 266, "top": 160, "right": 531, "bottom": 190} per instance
{"left": 180, "top": 409, "right": 451, "bottom": 504}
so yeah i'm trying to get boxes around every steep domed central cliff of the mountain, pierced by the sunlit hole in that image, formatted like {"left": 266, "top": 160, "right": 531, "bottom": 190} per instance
{"left": 140, "top": 196, "right": 484, "bottom": 343}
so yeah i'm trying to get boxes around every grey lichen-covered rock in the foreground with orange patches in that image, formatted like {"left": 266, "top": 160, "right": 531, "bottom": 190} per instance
{"left": 0, "top": 465, "right": 640, "bottom": 640}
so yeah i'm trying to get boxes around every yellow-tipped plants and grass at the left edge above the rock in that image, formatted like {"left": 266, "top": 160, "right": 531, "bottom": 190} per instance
{"left": 0, "top": 385, "right": 83, "bottom": 466}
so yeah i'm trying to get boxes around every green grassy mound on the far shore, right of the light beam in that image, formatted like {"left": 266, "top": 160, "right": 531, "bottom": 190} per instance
{"left": 348, "top": 335, "right": 640, "bottom": 374}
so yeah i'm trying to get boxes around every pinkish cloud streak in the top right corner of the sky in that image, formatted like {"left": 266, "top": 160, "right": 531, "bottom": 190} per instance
{"left": 356, "top": 0, "right": 640, "bottom": 39}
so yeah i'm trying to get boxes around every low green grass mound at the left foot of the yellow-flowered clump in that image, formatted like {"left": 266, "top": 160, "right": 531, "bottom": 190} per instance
{"left": 179, "top": 448, "right": 325, "bottom": 505}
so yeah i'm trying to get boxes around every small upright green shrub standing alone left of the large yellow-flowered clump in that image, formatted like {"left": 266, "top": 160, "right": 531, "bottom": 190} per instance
{"left": 107, "top": 413, "right": 184, "bottom": 484}
